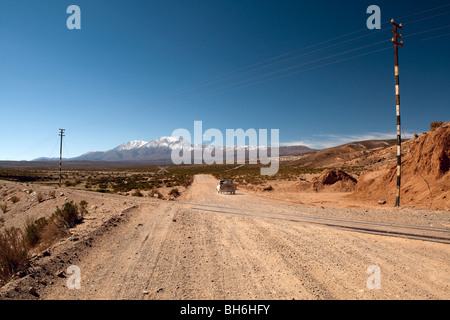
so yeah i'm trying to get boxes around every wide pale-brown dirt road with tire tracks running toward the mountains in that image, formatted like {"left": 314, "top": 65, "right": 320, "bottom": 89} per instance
{"left": 29, "top": 175, "right": 450, "bottom": 300}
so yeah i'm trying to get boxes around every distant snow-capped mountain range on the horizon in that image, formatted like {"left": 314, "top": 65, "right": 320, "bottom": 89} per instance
{"left": 32, "top": 137, "right": 315, "bottom": 163}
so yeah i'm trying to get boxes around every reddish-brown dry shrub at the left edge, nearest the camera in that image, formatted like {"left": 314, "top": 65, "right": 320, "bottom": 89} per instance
{"left": 0, "top": 228, "right": 28, "bottom": 282}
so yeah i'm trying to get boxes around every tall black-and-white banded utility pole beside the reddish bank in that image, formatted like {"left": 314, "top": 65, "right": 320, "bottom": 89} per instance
{"left": 391, "top": 19, "right": 403, "bottom": 207}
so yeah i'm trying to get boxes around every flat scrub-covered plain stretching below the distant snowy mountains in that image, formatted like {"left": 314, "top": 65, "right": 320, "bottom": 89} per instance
{"left": 0, "top": 163, "right": 328, "bottom": 201}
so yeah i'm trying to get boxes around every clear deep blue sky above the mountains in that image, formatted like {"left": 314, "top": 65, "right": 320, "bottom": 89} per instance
{"left": 0, "top": 0, "right": 450, "bottom": 160}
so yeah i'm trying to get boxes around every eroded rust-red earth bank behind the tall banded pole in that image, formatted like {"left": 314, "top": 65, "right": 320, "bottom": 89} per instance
{"left": 352, "top": 123, "right": 450, "bottom": 210}
